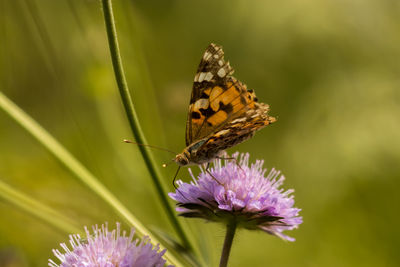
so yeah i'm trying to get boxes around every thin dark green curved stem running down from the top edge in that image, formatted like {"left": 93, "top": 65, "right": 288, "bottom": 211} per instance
{"left": 102, "top": 0, "right": 191, "bottom": 250}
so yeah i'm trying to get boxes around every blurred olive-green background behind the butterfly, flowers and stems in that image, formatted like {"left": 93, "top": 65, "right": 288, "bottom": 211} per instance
{"left": 0, "top": 0, "right": 400, "bottom": 266}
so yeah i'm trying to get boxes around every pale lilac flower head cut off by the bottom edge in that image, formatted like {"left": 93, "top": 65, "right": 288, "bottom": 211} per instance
{"left": 49, "top": 223, "right": 172, "bottom": 267}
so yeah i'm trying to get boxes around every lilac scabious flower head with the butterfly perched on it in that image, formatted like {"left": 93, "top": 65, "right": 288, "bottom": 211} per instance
{"left": 169, "top": 153, "right": 302, "bottom": 241}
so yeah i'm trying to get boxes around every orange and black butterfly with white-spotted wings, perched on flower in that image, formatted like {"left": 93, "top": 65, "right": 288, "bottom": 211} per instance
{"left": 174, "top": 43, "right": 276, "bottom": 170}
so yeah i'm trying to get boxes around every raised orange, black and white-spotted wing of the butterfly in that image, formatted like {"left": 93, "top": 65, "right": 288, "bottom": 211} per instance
{"left": 186, "top": 44, "right": 275, "bottom": 149}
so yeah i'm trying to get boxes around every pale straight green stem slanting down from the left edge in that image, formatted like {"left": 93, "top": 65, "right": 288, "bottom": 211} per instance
{"left": 0, "top": 91, "right": 179, "bottom": 264}
